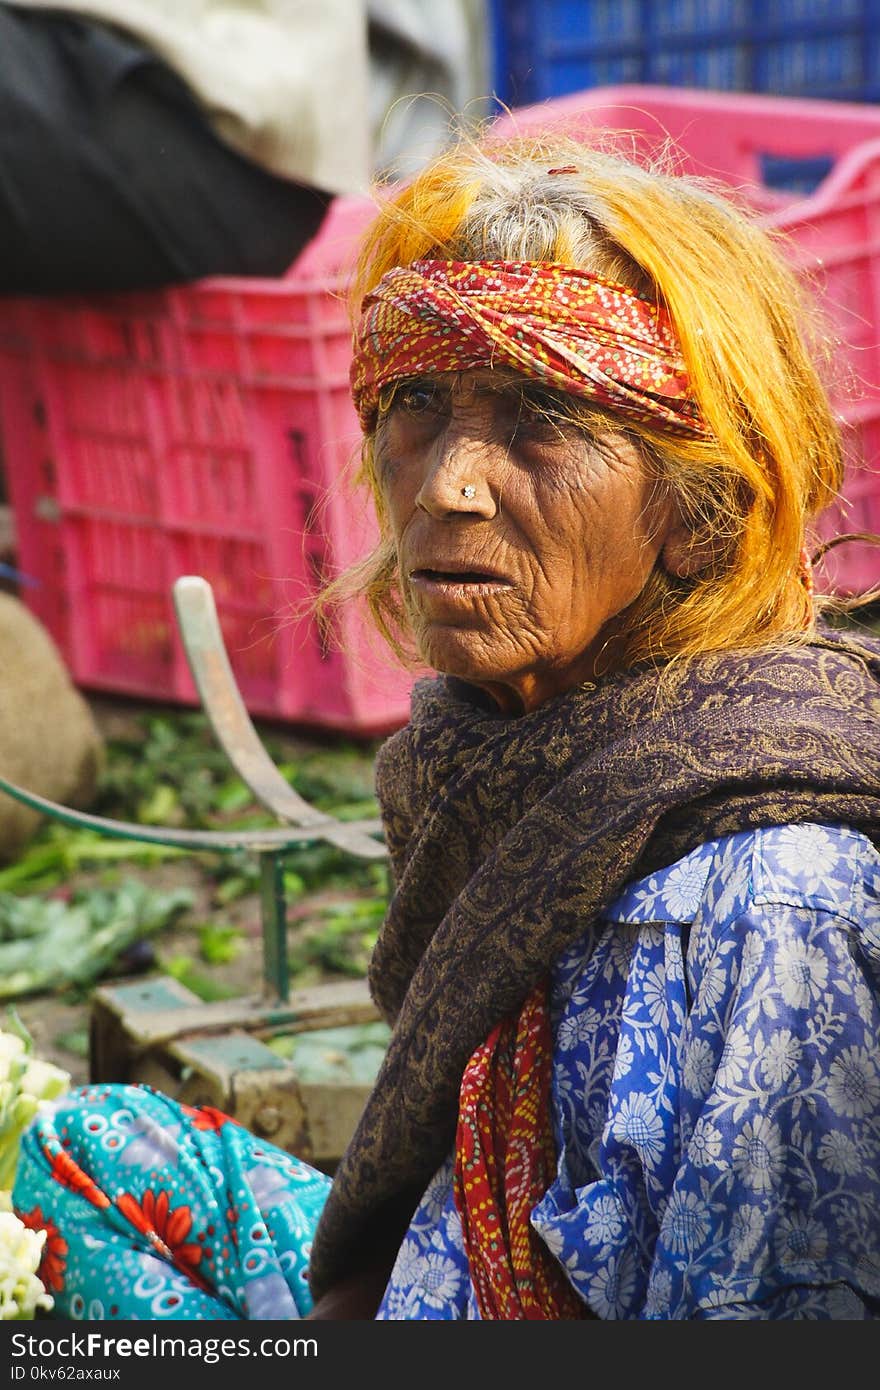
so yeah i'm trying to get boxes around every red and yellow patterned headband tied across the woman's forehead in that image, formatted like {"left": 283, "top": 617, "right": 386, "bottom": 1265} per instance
{"left": 352, "top": 260, "right": 708, "bottom": 438}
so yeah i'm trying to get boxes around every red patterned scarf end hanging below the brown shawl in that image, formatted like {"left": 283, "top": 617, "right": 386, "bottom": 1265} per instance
{"left": 453, "top": 986, "right": 589, "bottom": 1322}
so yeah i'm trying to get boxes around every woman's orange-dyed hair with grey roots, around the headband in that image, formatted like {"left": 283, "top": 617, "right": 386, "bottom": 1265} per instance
{"left": 318, "top": 133, "right": 842, "bottom": 664}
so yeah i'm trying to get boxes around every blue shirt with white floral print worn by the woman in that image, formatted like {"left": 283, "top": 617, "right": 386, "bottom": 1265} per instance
{"left": 378, "top": 824, "right": 880, "bottom": 1319}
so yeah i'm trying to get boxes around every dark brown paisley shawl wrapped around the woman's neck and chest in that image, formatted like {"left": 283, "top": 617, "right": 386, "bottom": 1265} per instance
{"left": 310, "top": 630, "right": 880, "bottom": 1297}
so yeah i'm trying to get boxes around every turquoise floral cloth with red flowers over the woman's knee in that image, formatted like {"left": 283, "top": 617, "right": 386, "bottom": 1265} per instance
{"left": 13, "top": 1086, "right": 329, "bottom": 1321}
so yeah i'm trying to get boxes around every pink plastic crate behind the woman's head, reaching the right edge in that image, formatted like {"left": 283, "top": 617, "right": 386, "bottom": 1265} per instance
{"left": 496, "top": 85, "right": 880, "bottom": 595}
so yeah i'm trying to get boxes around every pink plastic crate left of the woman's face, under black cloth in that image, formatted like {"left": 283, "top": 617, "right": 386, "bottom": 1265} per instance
{"left": 0, "top": 199, "right": 413, "bottom": 735}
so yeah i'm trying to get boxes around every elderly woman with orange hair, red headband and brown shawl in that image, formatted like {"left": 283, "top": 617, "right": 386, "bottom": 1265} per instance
{"left": 8, "top": 140, "right": 880, "bottom": 1319}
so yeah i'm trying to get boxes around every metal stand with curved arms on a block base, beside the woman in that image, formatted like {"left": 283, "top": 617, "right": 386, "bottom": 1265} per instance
{"left": 0, "top": 575, "right": 386, "bottom": 1170}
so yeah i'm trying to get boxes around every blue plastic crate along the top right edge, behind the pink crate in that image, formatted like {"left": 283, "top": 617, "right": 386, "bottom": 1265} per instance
{"left": 489, "top": 0, "right": 880, "bottom": 107}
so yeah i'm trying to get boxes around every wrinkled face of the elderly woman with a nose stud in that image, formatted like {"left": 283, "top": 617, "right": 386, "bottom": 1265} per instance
{"left": 375, "top": 370, "right": 683, "bottom": 713}
